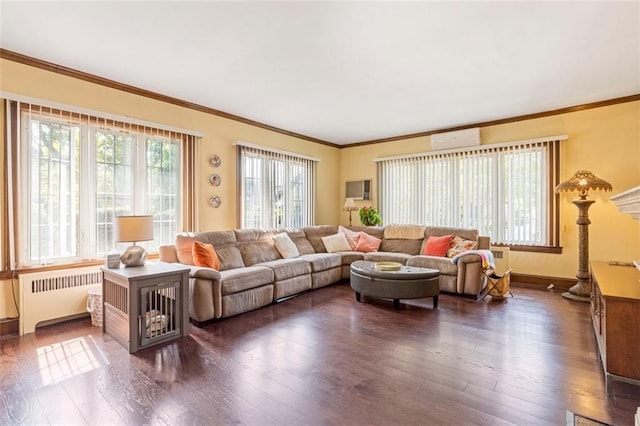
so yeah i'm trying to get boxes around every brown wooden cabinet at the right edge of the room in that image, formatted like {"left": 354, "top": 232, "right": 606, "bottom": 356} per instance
{"left": 591, "top": 262, "right": 640, "bottom": 395}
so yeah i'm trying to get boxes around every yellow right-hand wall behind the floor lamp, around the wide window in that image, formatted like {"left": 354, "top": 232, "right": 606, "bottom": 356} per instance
{"left": 340, "top": 102, "right": 640, "bottom": 278}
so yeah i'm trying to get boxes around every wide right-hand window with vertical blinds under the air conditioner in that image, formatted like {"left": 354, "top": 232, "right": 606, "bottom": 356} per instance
{"left": 378, "top": 137, "right": 566, "bottom": 246}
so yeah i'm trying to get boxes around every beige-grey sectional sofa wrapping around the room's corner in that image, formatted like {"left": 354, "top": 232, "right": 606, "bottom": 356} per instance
{"left": 160, "top": 225, "right": 489, "bottom": 323}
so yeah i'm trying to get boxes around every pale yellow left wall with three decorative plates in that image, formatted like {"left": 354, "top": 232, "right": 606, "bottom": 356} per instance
{"left": 0, "top": 59, "right": 340, "bottom": 318}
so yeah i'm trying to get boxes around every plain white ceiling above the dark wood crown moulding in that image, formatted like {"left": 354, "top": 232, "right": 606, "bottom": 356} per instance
{"left": 0, "top": 1, "right": 640, "bottom": 145}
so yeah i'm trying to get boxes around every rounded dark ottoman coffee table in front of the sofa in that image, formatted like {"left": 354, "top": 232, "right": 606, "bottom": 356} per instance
{"left": 350, "top": 260, "right": 440, "bottom": 309}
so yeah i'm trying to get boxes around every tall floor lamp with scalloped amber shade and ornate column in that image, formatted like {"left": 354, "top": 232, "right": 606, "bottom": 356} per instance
{"left": 556, "top": 170, "right": 613, "bottom": 302}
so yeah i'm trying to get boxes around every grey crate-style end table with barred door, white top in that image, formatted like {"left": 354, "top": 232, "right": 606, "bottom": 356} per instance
{"left": 102, "top": 262, "right": 190, "bottom": 353}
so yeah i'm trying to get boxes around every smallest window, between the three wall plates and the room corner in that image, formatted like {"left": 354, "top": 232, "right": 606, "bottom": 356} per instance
{"left": 238, "top": 144, "right": 317, "bottom": 228}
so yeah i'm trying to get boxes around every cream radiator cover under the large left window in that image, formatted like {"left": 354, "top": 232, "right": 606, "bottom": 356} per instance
{"left": 18, "top": 265, "right": 102, "bottom": 335}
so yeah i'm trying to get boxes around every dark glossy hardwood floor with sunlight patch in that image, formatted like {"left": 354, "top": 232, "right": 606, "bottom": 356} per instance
{"left": 0, "top": 284, "right": 640, "bottom": 425}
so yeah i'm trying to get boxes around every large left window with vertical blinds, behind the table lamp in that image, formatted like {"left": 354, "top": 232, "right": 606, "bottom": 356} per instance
{"left": 5, "top": 103, "right": 193, "bottom": 266}
